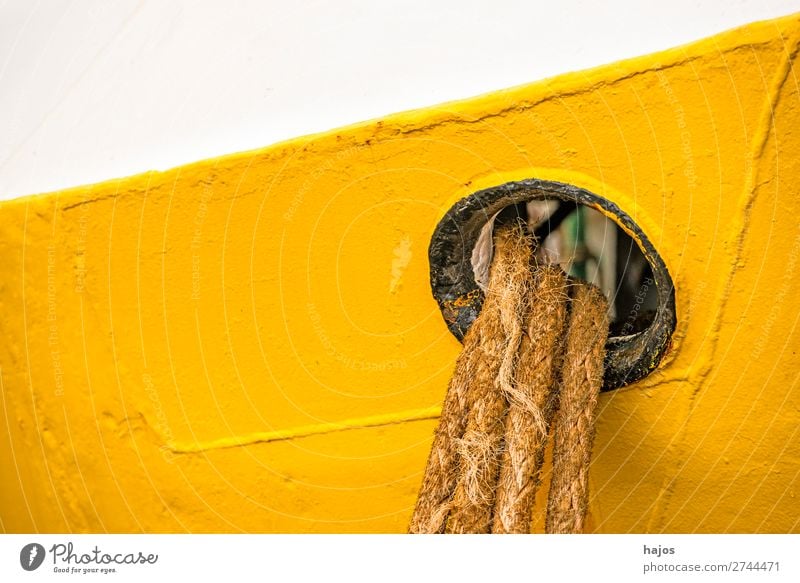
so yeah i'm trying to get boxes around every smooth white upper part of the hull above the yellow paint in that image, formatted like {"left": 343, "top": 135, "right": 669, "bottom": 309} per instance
{"left": 0, "top": 0, "right": 800, "bottom": 198}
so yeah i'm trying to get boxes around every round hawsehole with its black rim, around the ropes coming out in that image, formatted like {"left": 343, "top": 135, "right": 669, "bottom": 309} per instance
{"left": 429, "top": 179, "right": 676, "bottom": 390}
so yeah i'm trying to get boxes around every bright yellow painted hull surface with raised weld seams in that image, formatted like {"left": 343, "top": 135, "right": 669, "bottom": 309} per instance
{"left": 0, "top": 15, "right": 800, "bottom": 532}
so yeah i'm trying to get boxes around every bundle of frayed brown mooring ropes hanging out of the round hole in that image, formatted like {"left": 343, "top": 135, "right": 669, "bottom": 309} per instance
{"left": 409, "top": 225, "right": 608, "bottom": 533}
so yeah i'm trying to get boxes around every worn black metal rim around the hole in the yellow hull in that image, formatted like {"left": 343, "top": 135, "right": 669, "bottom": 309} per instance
{"left": 428, "top": 179, "right": 677, "bottom": 391}
